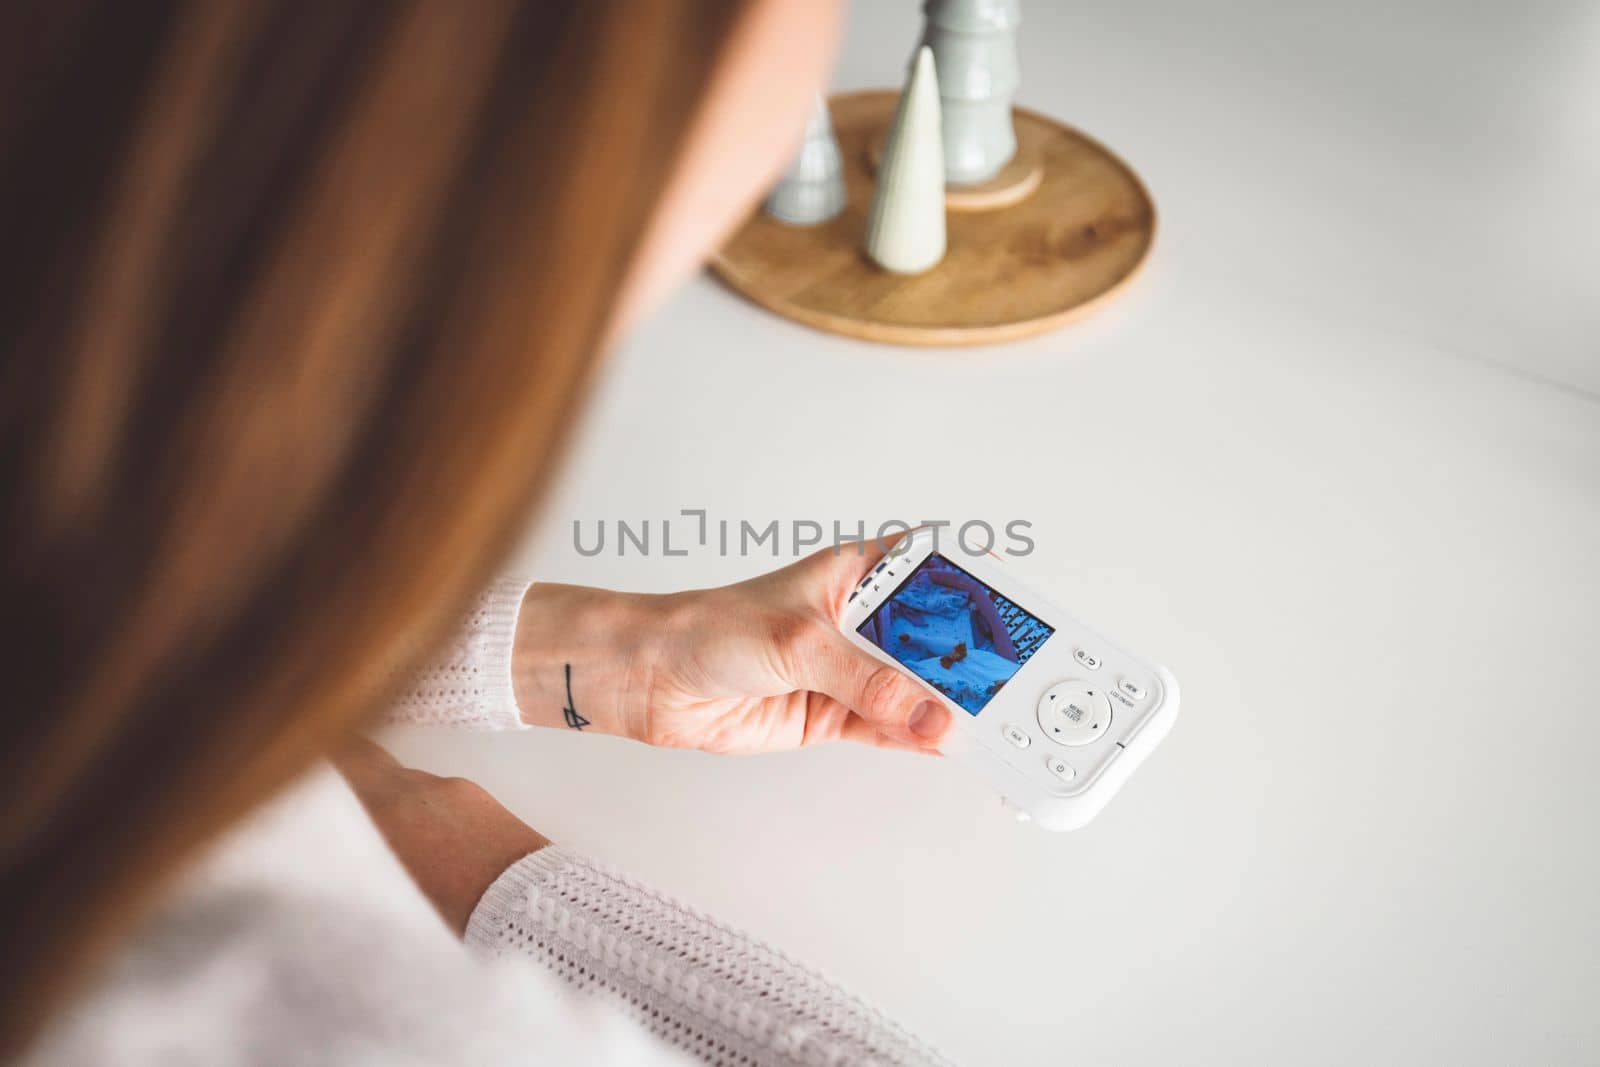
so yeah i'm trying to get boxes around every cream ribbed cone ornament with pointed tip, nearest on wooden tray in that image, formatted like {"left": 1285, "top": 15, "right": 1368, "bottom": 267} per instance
{"left": 864, "top": 48, "right": 944, "bottom": 274}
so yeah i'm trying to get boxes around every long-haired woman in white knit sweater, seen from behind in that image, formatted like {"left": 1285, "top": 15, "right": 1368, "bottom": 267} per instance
{"left": 0, "top": 0, "right": 950, "bottom": 1064}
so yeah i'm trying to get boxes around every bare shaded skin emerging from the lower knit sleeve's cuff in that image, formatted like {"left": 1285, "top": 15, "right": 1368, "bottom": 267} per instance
{"left": 333, "top": 739, "right": 550, "bottom": 934}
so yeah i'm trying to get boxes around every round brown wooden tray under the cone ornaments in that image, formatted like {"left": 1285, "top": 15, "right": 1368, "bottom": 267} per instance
{"left": 710, "top": 90, "right": 1155, "bottom": 346}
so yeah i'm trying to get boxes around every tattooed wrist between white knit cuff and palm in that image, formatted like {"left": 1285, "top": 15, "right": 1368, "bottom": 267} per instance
{"left": 510, "top": 582, "right": 664, "bottom": 739}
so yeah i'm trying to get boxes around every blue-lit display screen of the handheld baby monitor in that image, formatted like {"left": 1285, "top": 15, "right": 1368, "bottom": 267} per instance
{"left": 856, "top": 553, "right": 1056, "bottom": 715}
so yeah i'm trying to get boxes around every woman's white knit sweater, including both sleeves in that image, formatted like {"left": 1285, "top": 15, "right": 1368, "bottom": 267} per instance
{"left": 29, "top": 582, "right": 944, "bottom": 1067}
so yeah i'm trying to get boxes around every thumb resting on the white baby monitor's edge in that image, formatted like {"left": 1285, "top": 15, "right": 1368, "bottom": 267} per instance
{"left": 789, "top": 625, "right": 954, "bottom": 749}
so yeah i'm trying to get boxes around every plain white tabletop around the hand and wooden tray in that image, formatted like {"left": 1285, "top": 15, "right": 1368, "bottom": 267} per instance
{"left": 380, "top": 0, "right": 1600, "bottom": 1067}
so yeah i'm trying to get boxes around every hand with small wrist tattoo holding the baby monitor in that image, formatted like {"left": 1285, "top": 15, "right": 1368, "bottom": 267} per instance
{"left": 512, "top": 545, "right": 952, "bottom": 752}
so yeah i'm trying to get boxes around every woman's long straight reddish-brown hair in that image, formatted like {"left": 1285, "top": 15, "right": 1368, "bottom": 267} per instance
{"left": 0, "top": 0, "right": 738, "bottom": 1051}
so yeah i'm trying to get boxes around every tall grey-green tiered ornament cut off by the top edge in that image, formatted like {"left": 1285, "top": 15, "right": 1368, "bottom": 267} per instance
{"left": 922, "top": 0, "right": 1022, "bottom": 186}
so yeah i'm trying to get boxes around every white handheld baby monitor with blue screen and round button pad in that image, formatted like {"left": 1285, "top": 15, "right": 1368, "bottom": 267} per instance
{"left": 840, "top": 530, "right": 1178, "bottom": 830}
